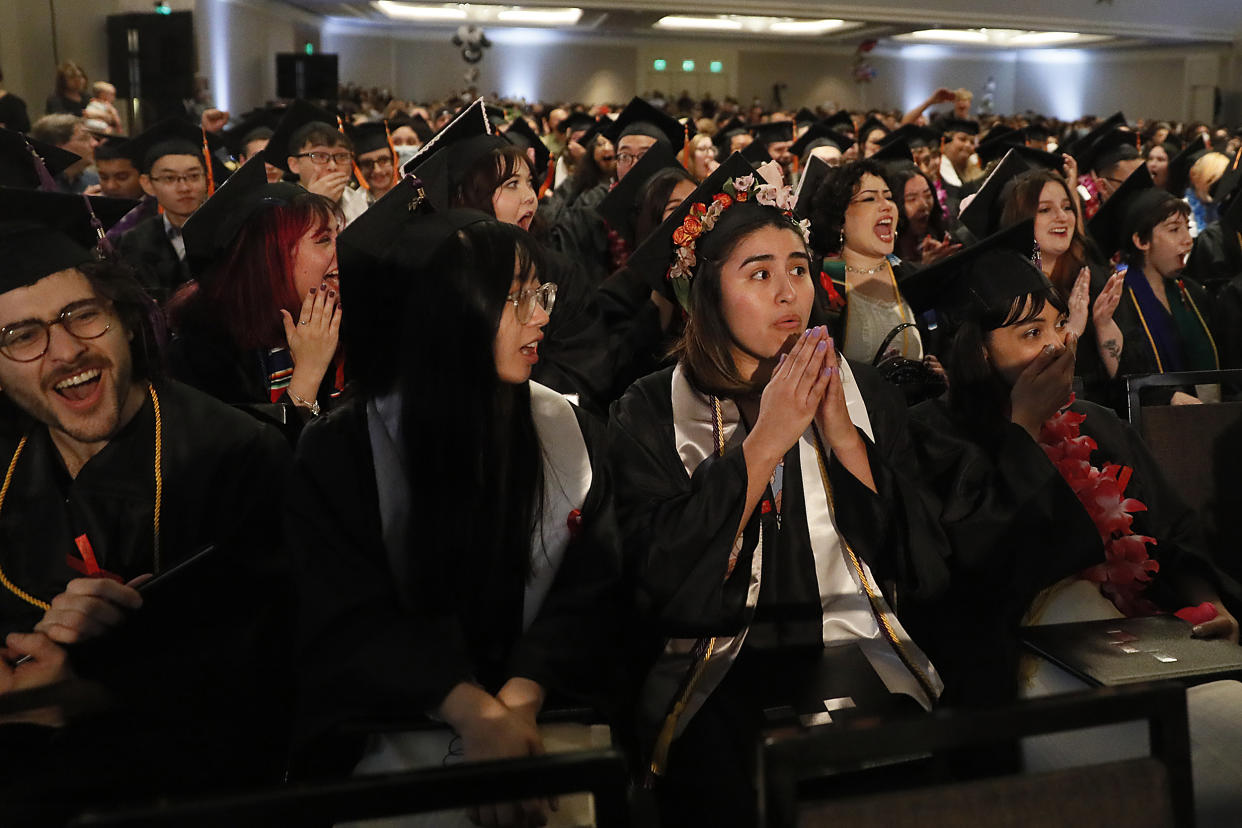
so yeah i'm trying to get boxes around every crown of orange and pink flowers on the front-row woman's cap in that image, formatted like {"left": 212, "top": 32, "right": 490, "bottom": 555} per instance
{"left": 666, "top": 161, "right": 811, "bottom": 308}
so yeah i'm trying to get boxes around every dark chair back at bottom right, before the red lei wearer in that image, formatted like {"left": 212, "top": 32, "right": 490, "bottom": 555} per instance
{"left": 760, "top": 683, "right": 1194, "bottom": 828}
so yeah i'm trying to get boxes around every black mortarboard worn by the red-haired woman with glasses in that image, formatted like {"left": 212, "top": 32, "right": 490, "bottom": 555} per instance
{"left": 181, "top": 155, "right": 306, "bottom": 279}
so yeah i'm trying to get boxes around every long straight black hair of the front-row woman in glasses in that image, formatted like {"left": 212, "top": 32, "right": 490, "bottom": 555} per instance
{"left": 395, "top": 221, "right": 544, "bottom": 663}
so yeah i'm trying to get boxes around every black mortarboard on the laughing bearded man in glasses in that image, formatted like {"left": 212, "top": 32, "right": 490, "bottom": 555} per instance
{"left": 0, "top": 186, "right": 138, "bottom": 293}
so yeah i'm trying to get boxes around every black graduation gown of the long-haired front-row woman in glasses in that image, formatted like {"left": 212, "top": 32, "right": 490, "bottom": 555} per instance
{"left": 284, "top": 400, "right": 620, "bottom": 775}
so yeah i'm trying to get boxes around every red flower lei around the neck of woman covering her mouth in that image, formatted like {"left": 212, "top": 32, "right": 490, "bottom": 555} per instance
{"left": 1040, "top": 396, "right": 1160, "bottom": 617}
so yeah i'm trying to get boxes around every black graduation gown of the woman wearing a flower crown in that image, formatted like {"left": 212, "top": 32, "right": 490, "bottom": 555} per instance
{"left": 609, "top": 362, "right": 945, "bottom": 826}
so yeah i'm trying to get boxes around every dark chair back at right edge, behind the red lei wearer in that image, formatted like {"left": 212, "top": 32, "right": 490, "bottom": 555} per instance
{"left": 1125, "top": 370, "right": 1242, "bottom": 577}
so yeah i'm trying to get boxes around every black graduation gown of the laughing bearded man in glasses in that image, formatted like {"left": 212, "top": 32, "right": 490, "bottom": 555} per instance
{"left": 0, "top": 381, "right": 291, "bottom": 824}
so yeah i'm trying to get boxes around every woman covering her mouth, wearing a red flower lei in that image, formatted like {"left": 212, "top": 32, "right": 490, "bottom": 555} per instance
{"left": 905, "top": 220, "right": 1242, "bottom": 824}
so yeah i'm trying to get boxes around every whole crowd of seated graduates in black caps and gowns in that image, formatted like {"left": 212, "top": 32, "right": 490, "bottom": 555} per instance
{"left": 0, "top": 67, "right": 1242, "bottom": 826}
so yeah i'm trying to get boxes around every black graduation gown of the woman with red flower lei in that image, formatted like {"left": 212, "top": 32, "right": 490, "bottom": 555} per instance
{"left": 907, "top": 400, "right": 1240, "bottom": 704}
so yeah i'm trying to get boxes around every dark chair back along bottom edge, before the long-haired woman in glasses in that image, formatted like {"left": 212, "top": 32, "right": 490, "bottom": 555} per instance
{"left": 70, "top": 750, "right": 628, "bottom": 828}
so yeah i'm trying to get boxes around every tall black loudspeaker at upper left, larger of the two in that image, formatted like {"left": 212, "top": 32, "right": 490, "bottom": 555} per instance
{"left": 108, "top": 11, "right": 196, "bottom": 127}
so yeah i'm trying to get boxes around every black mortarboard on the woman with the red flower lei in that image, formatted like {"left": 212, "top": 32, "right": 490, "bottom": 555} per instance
{"left": 902, "top": 218, "right": 1052, "bottom": 322}
